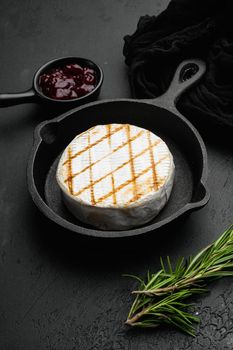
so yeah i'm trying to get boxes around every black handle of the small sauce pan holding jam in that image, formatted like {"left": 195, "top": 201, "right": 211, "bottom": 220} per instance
{"left": 0, "top": 89, "right": 36, "bottom": 108}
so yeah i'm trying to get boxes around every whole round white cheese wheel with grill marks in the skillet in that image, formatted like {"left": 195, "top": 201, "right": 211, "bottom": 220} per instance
{"left": 57, "top": 124, "right": 175, "bottom": 230}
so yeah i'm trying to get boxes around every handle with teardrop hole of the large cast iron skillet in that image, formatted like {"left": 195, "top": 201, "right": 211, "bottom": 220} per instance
{"left": 150, "top": 59, "right": 206, "bottom": 112}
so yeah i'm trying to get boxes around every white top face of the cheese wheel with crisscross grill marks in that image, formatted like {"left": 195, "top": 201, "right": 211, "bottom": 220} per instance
{"left": 57, "top": 124, "right": 173, "bottom": 208}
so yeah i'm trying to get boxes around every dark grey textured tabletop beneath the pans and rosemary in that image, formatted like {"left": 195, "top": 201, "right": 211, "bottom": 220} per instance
{"left": 0, "top": 0, "right": 233, "bottom": 350}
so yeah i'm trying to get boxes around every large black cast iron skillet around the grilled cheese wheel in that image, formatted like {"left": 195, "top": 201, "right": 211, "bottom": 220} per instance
{"left": 28, "top": 59, "right": 209, "bottom": 238}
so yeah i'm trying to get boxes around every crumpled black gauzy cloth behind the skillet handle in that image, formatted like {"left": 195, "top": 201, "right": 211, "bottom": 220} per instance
{"left": 123, "top": 0, "right": 233, "bottom": 126}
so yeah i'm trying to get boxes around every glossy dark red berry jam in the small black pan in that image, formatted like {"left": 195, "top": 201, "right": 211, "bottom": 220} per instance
{"left": 39, "top": 63, "right": 97, "bottom": 100}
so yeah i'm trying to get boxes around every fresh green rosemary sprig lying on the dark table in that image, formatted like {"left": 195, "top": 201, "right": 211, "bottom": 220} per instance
{"left": 126, "top": 225, "right": 233, "bottom": 336}
